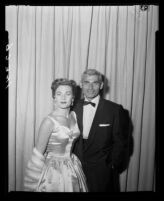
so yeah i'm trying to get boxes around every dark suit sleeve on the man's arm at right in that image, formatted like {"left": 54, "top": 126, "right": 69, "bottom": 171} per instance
{"left": 112, "top": 105, "right": 129, "bottom": 169}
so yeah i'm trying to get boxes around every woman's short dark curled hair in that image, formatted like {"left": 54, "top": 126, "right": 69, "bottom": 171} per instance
{"left": 51, "top": 78, "right": 76, "bottom": 98}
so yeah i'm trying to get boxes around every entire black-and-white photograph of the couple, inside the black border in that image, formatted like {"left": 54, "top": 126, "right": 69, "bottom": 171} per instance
{"left": 5, "top": 4, "right": 159, "bottom": 195}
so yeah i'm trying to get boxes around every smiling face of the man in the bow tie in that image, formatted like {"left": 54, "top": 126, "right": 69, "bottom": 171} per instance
{"left": 82, "top": 75, "right": 103, "bottom": 100}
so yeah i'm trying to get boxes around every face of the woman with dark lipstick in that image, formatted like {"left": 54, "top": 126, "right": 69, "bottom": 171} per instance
{"left": 54, "top": 85, "right": 73, "bottom": 109}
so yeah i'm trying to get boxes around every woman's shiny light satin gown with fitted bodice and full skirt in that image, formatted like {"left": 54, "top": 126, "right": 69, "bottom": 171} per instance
{"left": 23, "top": 112, "right": 88, "bottom": 192}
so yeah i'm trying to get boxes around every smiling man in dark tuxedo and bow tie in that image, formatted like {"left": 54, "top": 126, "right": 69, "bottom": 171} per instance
{"left": 73, "top": 69, "right": 127, "bottom": 192}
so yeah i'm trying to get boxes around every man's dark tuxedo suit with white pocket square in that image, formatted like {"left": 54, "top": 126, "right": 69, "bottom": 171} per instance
{"left": 73, "top": 98, "right": 129, "bottom": 192}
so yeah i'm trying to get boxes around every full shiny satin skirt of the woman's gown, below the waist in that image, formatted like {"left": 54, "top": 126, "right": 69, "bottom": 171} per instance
{"left": 36, "top": 153, "right": 87, "bottom": 192}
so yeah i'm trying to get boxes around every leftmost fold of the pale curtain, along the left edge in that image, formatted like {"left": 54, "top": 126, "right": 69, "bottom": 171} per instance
{"left": 5, "top": 6, "right": 18, "bottom": 190}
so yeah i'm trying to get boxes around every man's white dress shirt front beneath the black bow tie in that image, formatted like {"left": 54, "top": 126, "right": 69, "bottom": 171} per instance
{"left": 83, "top": 95, "right": 100, "bottom": 139}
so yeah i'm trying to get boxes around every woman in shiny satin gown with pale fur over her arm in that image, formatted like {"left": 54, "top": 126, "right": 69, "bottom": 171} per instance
{"left": 24, "top": 79, "right": 88, "bottom": 192}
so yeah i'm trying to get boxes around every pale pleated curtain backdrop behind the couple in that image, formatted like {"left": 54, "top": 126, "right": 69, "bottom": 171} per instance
{"left": 6, "top": 5, "right": 158, "bottom": 192}
